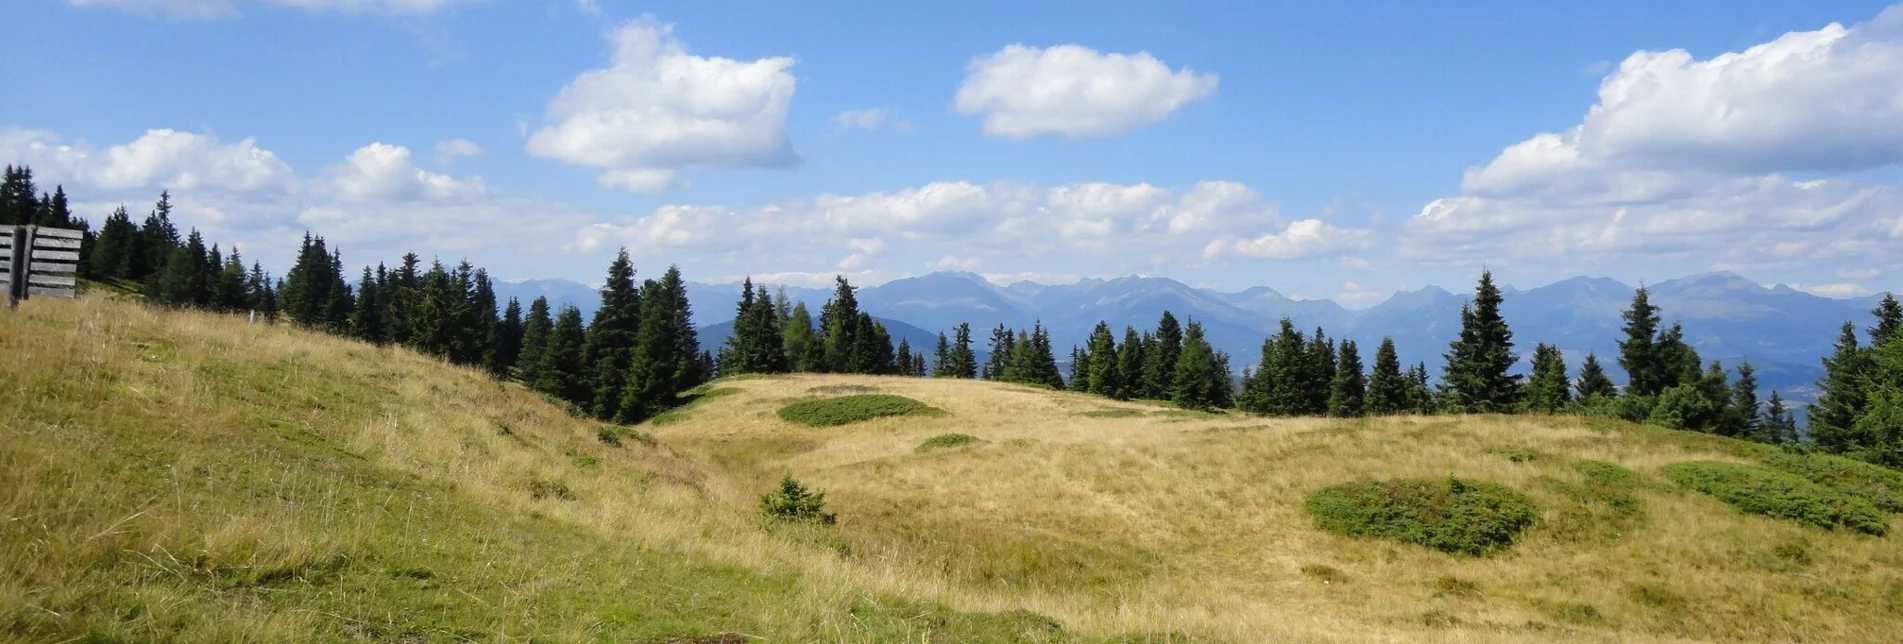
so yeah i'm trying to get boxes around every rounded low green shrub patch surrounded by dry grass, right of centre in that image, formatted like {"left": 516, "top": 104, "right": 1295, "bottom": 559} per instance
{"left": 1304, "top": 476, "right": 1536, "bottom": 556}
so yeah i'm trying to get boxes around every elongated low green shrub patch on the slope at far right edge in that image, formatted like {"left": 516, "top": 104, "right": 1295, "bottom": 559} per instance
{"left": 1665, "top": 461, "right": 1890, "bottom": 535}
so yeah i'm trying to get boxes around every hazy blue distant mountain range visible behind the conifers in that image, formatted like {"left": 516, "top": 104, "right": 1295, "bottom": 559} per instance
{"left": 497, "top": 272, "right": 1880, "bottom": 400}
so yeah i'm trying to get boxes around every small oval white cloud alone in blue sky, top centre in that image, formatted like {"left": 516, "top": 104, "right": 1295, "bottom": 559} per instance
{"left": 953, "top": 44, "right": 1218, "bottom": 139}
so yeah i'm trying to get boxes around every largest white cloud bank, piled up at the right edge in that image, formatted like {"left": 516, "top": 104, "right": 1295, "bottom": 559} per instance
{"left": 1401, "top": 8, "right": 1903, "bottom": 276}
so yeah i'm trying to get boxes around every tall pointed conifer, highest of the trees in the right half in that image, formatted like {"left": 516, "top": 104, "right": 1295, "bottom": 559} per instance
{"left": 1441, "top": 271, "right": 1520, "bottom": 413}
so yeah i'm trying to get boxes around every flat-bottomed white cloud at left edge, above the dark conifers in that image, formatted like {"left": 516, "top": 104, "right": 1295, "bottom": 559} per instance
{"left": 0, "top": 128, "right": 297, "bottom": 192}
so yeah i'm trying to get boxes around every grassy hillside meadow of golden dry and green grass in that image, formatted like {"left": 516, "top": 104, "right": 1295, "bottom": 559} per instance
{"left": 0, "top": 297, "right": 1903, "bottom": 642}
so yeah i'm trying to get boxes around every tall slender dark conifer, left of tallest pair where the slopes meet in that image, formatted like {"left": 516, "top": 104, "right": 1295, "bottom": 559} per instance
{"left": 582, "top": 248, "right": 645, "bottom": 419}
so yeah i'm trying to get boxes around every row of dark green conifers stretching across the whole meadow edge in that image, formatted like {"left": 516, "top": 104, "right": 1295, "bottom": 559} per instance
{"left": 14, "top": 166, "right": 1903, "bottom": 467}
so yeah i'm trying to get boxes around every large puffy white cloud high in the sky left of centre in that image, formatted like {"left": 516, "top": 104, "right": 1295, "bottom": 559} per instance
{"left": 527, "top": 19, "right": 799, "bottom": 192}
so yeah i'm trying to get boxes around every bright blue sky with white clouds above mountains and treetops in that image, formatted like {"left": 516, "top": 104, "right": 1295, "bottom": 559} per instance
{"left": 0, "top": 0, "right": 1903, "bottom": 307}
